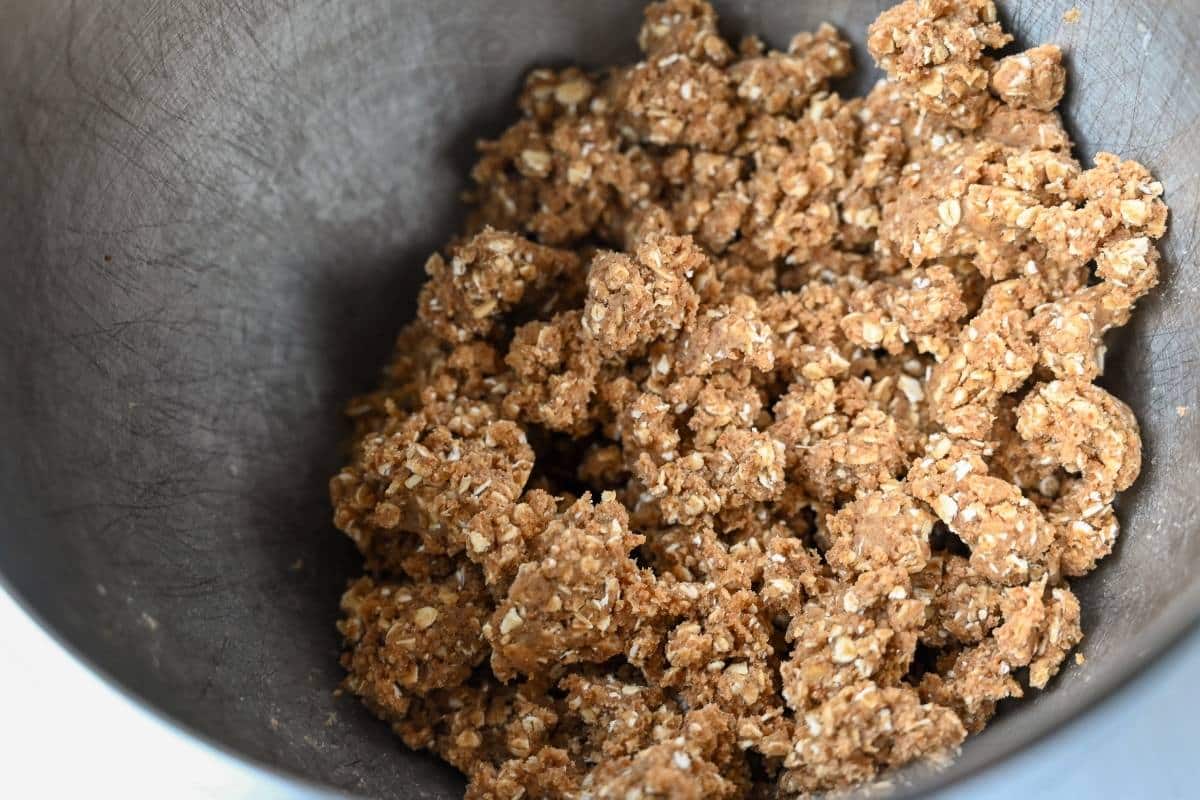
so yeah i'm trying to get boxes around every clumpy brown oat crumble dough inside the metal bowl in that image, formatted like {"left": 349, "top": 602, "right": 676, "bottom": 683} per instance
{"left": 331, "top": 0, "right": 1166, "bottom": 800}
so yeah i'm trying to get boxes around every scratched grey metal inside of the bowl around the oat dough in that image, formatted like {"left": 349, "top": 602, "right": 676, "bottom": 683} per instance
{"left": 0, "top": 0, "right": 1200, "bottom": 798}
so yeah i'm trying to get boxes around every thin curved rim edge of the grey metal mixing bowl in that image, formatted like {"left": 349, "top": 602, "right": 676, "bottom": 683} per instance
{"left": 0, "top": 566, "right": 1200, "bottom": 800}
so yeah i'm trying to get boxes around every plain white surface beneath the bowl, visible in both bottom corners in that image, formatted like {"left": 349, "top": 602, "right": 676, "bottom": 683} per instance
{"left": 0, "top": 590, "right": 1200, "bottom": 800}
